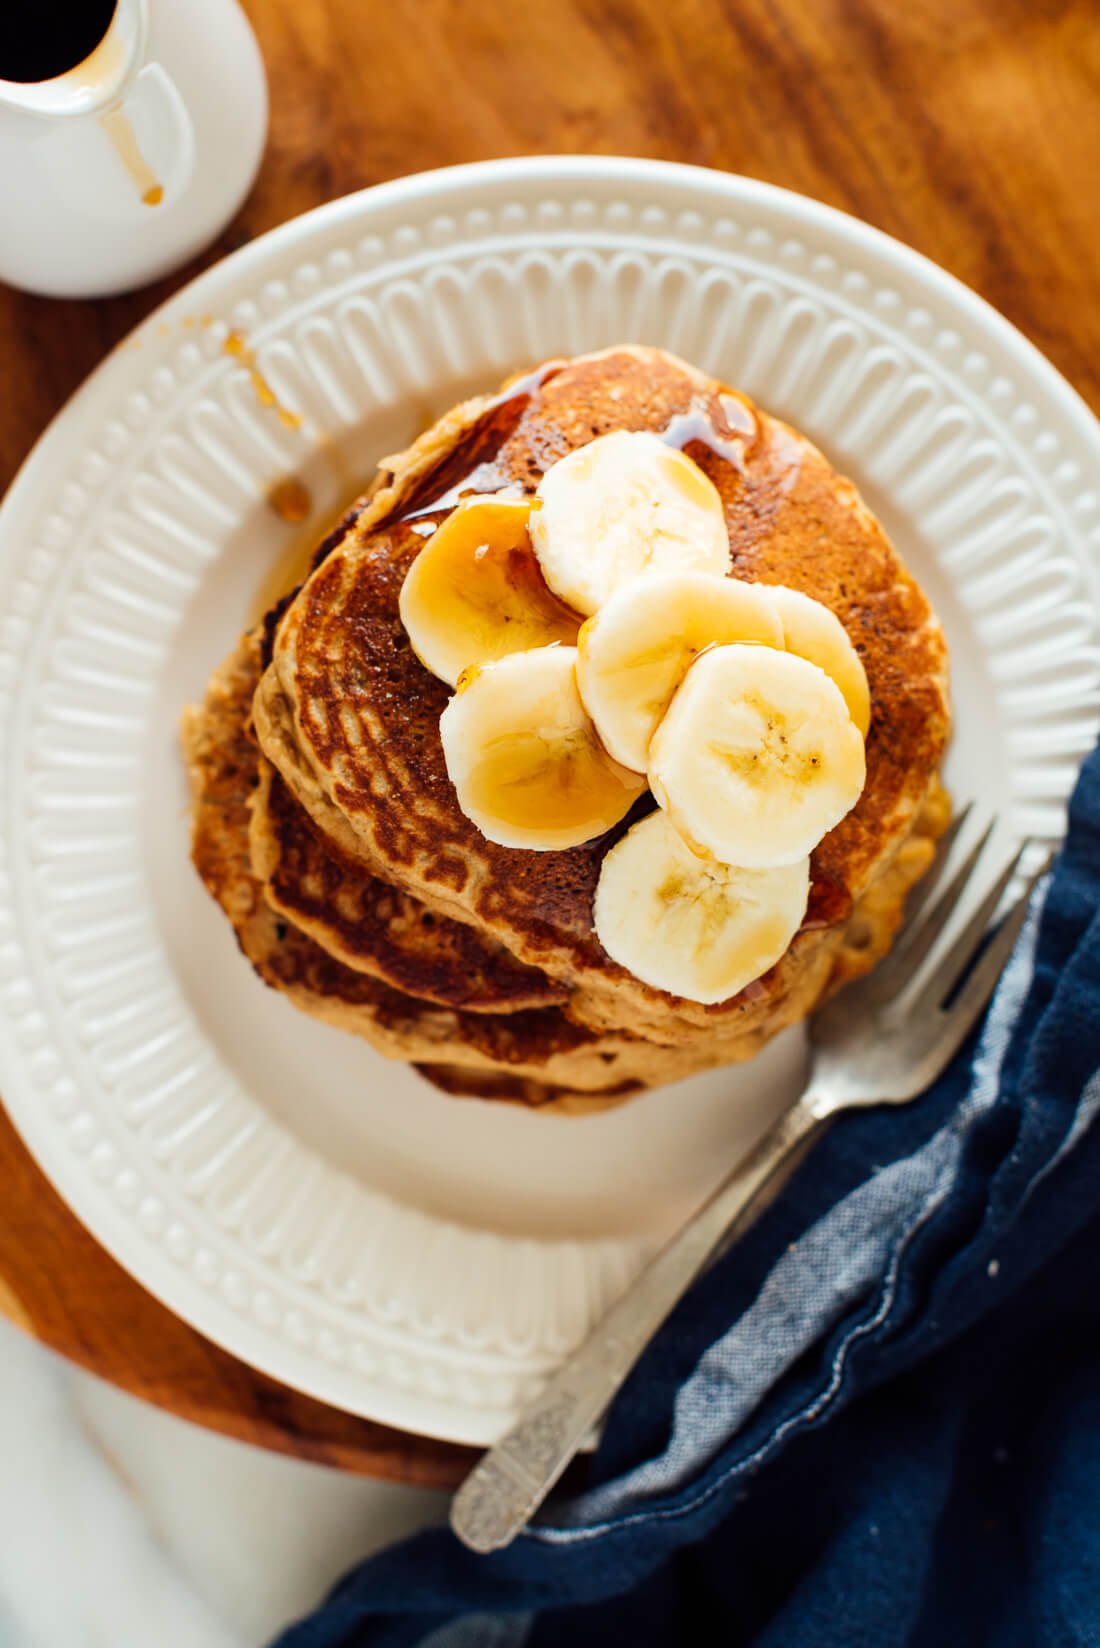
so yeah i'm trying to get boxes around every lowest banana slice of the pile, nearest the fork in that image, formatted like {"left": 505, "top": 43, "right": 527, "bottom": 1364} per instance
{"left": 594, "top": 812, "right": 810, "bottom": 1005}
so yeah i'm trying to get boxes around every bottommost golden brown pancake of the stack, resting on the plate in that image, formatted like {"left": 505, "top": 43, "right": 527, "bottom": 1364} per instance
{"left": 185, "top": 634, "right": 947, "bottom": 1114}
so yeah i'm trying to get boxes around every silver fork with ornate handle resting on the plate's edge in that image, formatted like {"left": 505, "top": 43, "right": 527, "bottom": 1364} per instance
{"left": 450, "top": 809, "right": 1047, "bottom": 1552}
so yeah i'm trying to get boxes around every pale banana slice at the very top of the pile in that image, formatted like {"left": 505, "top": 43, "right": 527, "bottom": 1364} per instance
{"left": 531, "top": 430, "right": 729, "bottom": 615}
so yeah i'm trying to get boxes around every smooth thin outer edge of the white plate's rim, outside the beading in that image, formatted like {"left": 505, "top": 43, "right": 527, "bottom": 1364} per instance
{"left": 0, "top": 157, "right": 1100, "bottom": 1442}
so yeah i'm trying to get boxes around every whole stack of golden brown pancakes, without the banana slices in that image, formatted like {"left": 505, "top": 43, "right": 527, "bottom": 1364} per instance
{"left": 185, "top": 348, "right": 948, "bottom": 1107}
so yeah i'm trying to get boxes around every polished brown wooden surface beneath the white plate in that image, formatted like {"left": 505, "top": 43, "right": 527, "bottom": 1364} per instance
{"left": 0, "top": 0, "right": 1100, "bottom": 1483}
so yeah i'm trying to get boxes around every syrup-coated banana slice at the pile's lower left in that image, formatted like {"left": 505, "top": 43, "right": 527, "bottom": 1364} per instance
{"left": 439, "top": 646, "right": 645, "bottom": 852}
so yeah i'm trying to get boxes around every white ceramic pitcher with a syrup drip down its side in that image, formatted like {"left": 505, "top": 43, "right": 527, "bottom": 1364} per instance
{"left": 0, "top": 0, "right": 267, "bottom": 297}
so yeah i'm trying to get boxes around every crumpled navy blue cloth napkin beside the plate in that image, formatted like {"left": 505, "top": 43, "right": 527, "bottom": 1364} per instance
{"left": 279, "top": 750, "right": 1100, "bottom": 1648}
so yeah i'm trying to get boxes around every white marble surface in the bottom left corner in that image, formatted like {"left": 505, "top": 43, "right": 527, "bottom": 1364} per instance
{"left": 0, "top": 1323, "right": 447, "bottom": 1648}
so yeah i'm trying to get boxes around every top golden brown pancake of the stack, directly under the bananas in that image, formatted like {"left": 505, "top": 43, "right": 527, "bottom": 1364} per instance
{"left": 254, "top": 349, "right": 948, "bottom": 1041}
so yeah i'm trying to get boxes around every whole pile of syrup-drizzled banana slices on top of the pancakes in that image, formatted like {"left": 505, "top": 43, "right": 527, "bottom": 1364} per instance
{"left": 417, "top": 432, "right": 871, "bottom": 1004}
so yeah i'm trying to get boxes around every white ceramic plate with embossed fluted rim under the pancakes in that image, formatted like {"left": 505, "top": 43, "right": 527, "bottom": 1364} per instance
{"left": 0, "top": 160, "right": 1100, "bottom": 1442}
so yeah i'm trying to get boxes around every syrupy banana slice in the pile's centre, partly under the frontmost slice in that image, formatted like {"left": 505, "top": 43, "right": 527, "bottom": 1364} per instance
{"left": 577, "top": 572, "right": 783, "bottom": 773}
